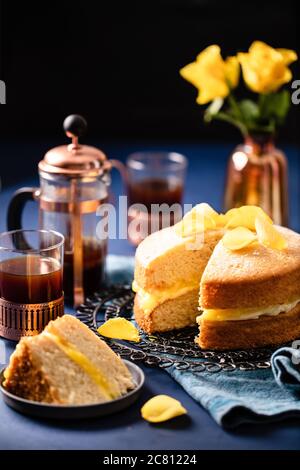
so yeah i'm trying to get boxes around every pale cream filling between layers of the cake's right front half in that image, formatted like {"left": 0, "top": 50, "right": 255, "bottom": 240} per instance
{"left": 197, "top": 299, "right": 300, "bottom": 323}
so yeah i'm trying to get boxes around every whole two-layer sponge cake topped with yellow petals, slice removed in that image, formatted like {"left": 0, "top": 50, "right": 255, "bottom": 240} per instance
{"left": 133, "top": 204, "right": 300, "bottom": 349}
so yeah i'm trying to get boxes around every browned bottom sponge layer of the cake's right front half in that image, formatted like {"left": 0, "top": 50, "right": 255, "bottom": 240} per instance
{"left": 196, "top": 302, "right": 300, "bottom": 350}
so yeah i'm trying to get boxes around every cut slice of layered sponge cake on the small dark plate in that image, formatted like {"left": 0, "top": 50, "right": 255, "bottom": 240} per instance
{"left": 4, "top": 315, "right": 134, "bottom": 405}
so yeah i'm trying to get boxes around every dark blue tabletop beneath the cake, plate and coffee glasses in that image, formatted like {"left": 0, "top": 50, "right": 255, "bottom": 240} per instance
{"left": 0, "top": 143, "right": 300, "bottom": 450}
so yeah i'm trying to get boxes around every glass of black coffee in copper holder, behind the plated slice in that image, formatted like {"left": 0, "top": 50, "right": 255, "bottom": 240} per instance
{"left": 0, "top": 230, "right": 64, "bottom": 341}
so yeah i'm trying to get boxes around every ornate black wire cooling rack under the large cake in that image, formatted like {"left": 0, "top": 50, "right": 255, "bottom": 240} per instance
{"left": 77, "top": 285, "right": 284, "bottom": 373}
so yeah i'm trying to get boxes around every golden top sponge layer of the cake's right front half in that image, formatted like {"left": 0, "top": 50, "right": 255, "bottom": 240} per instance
{"left": 200, "top": 227, "right": 300, "bottom": 309}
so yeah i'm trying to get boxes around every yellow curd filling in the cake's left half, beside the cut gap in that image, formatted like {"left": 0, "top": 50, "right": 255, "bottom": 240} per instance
{"left": 132, "top": 281, "right": 199, "bottom": 315}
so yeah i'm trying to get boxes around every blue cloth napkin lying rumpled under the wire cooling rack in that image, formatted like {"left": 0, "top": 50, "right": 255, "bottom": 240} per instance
{"left": 108, "top": 256, "right": 300, "bottom": 428}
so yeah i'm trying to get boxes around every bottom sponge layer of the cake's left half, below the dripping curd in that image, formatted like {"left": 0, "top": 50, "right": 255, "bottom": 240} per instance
{"left": 134, "top": 288, "right": 199, "bottom": 334}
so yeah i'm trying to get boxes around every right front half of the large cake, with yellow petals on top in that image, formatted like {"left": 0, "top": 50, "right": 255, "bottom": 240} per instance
{"left": 197, "top": 220, "right": 300, "bottom": 350}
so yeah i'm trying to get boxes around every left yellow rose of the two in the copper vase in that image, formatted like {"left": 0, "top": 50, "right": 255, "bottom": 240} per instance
{"left": 180, "top": 45, "right": 240, "bottom": 104}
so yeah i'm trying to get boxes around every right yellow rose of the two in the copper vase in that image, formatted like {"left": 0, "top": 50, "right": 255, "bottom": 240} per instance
{"left": 237, "top": 41, "right": 298, "bottom": 93}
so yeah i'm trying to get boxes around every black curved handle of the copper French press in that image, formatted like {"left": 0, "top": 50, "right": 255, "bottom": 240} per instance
{"left": 6, "top": 188, "right": 39, "bottom": 231}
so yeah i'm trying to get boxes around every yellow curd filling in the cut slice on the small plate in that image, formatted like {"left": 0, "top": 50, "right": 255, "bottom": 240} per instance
{"left": 44, "top": 331, "right": 118, "bottom": 400}
